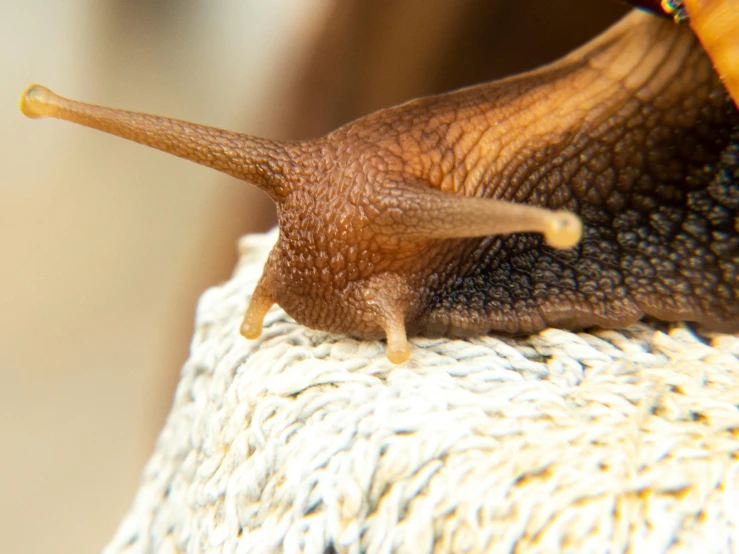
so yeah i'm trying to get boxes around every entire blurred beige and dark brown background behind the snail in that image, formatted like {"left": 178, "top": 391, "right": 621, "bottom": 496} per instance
{"left": 0, "top": 0, "right": 624, "bottom": 553}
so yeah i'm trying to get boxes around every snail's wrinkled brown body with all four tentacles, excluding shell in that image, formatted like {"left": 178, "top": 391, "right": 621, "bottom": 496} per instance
{"left": 20, "top": 10, "right": 739, "bottom": 363}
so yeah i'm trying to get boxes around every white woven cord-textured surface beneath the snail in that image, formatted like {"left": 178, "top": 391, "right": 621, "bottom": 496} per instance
{"left": 105, "top": 226, "right": 739, "bottom": 554}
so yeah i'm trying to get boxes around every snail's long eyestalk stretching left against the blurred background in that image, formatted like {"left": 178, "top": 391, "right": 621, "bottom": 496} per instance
{"left": 20, "top": 85, "right": 292, "bottom": 200}
